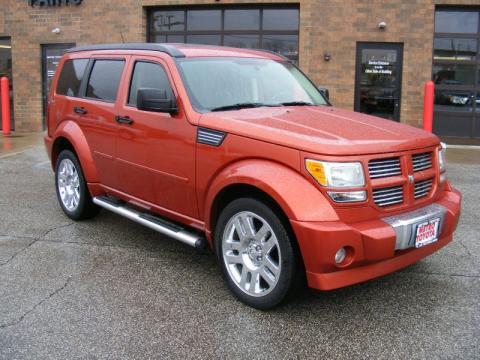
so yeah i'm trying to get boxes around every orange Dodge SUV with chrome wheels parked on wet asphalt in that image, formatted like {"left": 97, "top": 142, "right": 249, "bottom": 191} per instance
{"left": 45, "top": 44, "right": 461, "bottom": 309}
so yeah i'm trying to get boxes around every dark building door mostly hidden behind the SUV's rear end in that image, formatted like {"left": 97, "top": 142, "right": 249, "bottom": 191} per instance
{"left": 42, "top": 43, "right": 75, "bottom": 128}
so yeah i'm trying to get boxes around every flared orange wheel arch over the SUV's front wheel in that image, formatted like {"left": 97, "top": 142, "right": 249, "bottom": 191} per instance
{"left": 204, "top": 159, "right": 338, "bottom": 245}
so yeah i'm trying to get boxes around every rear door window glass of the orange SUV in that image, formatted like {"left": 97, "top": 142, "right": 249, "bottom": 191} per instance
{"left": 86, "top": 60, "right": 125, "bottom": 101}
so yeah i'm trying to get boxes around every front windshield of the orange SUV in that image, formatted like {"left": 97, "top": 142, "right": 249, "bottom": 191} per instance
{"left": 178, "top": 57, "right": 328, "bottom": 113}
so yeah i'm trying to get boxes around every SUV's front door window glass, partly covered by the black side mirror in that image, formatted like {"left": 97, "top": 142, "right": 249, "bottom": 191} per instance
{"left": 128, "top": 61, "right": 173, "bottom": 106}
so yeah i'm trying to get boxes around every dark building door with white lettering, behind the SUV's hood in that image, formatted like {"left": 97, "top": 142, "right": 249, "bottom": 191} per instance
{"left": 355, "top": 42, "right": 403, "bottom": 121}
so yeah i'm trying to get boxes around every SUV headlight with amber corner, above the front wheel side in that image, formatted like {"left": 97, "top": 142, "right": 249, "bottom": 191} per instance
{"left": 305, "top": 159, "right": 365, "bottom": 188}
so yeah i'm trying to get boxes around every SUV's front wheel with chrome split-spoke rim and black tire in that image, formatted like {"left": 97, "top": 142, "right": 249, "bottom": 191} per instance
{"left": 215, "top": 198, "right": 299, "bottom": 310}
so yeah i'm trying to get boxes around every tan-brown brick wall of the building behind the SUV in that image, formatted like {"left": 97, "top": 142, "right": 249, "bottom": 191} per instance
{"left": 0, "top": 0, "right": 478, "bottom": 131}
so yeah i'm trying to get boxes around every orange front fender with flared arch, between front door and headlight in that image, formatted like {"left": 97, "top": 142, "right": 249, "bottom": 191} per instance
{"left": 197, "top": 134, "right": 338, "bottom": 236}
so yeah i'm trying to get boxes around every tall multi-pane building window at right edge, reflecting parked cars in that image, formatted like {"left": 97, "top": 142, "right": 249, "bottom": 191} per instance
{"left": 432, "top": 7, "right": 480, "bottom": 138}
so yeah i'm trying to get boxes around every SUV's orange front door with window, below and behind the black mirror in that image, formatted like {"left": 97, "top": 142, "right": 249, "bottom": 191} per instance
{"left": 115, "top": 54, "right": 198, "bottom": 218}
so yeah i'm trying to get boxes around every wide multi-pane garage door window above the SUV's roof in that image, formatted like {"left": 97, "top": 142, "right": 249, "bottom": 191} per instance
{"left": 148, "top": 6, "right": 299, "bottom": 63}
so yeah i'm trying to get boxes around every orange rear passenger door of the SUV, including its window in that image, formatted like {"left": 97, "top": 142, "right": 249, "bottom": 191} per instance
{"left": 72, "top": 56, "right": 128, "bottom": 188}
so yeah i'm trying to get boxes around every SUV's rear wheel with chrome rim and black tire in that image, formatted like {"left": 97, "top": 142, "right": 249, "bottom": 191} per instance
{"left": 55, "top": 150, "right": 100, "bottom": 220}
